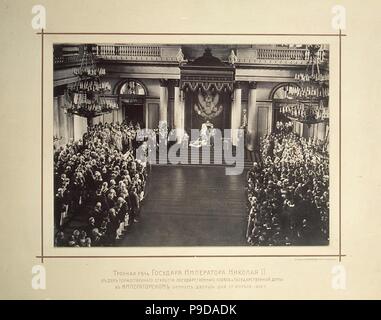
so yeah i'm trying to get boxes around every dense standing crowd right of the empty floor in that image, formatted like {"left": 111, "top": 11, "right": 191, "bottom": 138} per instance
{"left": 246, "top": 122, "right": 329, "bottom": 246}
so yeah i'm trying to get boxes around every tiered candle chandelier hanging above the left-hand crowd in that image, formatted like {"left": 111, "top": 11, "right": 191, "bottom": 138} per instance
{"left": 64, "top": 46, "right": 118, "bottom": 121}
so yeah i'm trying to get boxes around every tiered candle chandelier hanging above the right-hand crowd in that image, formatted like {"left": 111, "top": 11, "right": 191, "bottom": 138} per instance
{"left": 280, "top": 45, "right": 329, "bottom": 124}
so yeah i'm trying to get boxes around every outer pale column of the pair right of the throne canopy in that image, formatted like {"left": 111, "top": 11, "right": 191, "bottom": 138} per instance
{"left": 246, "top": 81, "right": 258, "bottom": 151}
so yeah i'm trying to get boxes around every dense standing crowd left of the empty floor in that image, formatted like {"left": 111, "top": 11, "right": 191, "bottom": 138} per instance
{"left": 54, "top": 122, "right": 148, "bottom": 247}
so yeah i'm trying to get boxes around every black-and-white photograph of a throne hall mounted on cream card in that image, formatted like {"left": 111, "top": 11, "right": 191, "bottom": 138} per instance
{"left": 52, "top": 43, "right": 329, "bottom": 247}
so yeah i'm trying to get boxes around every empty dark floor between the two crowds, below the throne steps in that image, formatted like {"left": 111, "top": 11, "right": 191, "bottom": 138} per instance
{"left": 118, "top": 165, "right": 247, "bottom": 246}
